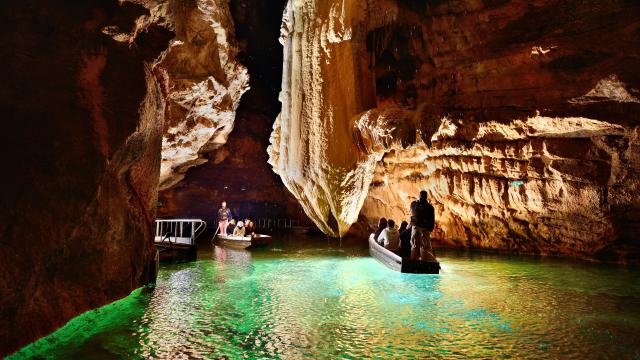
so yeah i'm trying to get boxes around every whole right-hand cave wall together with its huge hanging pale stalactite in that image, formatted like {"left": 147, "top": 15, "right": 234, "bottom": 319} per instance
{"left": 270, "top": 1, "right": 640, "bottom": 260}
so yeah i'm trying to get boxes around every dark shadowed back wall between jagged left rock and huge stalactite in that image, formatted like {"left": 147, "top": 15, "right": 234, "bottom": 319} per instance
{"left": 158, "top": 0, "right": 308, "bottom": 226}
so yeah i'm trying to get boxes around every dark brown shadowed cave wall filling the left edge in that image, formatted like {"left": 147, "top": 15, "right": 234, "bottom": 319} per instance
{"left": 0, "top": 0, "right": 173, "bottom": 356}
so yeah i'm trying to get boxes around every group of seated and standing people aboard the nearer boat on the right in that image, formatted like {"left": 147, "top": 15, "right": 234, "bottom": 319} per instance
{"left": 373, "top": 191, "right": 435, "bottom": 260}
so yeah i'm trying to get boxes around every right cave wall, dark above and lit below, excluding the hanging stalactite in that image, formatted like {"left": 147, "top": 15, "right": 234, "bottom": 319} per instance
{"left": 362, "top": 1, "right": 640, "bottom": 261}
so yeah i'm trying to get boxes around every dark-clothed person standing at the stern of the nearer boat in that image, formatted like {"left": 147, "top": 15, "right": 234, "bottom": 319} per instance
{"left": 411, "top": 190, "right": 435, "bottom": 260}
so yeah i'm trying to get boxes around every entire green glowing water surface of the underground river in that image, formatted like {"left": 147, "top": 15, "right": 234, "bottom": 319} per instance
{"left": 9, "top": 239, "right": 640, "bottom": 359}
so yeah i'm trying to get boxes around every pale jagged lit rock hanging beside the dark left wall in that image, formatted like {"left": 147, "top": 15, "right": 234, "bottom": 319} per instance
{"left": 158, "top": 0, "right": 249, "bottom": 190}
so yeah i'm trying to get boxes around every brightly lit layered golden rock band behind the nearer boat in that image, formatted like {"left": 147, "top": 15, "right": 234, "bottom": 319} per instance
{"left": 362, "top": 117, "right": 640, "bottom": 256}
